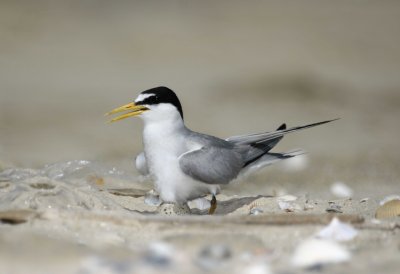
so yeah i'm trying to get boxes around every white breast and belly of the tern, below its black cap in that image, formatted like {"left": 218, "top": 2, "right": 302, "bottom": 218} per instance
{"left": 141, "top": 105, "right": 218, "bottom": 203}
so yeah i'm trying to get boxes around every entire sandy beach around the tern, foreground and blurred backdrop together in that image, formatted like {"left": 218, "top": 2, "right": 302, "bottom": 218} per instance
{"left": 0, "top": 0, "right": 400, "bottom": 273}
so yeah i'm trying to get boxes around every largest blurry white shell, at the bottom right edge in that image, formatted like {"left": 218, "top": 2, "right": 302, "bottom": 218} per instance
{"left": 291, "top": 239, "right": 351, "bottom": 268}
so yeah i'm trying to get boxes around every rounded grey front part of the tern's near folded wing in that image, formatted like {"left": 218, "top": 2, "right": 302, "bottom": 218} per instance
{"left": 179, "top": 146, "right": 244, "bottom": 184}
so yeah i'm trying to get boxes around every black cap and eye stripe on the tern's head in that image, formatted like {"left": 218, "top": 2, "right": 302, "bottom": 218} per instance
{"left": 136, "top": 87, "right": 183, "bottom": 120}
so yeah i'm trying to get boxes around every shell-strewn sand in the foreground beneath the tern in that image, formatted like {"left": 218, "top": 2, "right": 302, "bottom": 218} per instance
{"left": 0, "top": 161, "right": 400, "bottom": 273}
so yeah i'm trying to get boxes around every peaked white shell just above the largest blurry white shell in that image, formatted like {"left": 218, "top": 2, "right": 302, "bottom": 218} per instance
{"left": 316, "top": 218, "right": 358, "bottom": 242}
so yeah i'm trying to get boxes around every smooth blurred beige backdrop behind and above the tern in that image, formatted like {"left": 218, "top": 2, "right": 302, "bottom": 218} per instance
{"left": 0, "top": 0, "right": 400, "bottom": 196}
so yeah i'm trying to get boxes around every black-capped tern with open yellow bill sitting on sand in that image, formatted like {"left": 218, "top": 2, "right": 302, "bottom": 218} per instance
{"left": 106, "top": 87, "right": 333, "bottom": 214}
